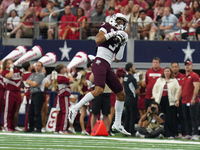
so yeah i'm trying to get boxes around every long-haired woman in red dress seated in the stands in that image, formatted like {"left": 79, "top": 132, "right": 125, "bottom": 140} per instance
{"left": 60, "top": 7, "right": 86, "bottom": 40}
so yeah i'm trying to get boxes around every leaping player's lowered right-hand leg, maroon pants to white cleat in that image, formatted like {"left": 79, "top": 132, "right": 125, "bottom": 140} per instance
{"left": 106, "top": 69, "right": 131, "bottom": 135}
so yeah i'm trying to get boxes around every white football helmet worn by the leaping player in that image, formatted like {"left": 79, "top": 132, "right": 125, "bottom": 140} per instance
{"left": 109, "top": 13, "right": 127, "bottom": 30}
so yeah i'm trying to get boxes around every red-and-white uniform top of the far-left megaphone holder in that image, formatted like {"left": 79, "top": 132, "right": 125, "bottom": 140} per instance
{"left": 1, "top": 69, "right": 21, "bottom": 91}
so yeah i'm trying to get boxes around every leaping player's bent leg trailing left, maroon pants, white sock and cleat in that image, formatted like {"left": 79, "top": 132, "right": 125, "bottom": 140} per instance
{"left": 68, "top": 58, "right": 109, "bottom": 123}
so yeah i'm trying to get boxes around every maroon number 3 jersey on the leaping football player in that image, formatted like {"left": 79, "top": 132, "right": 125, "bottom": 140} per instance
{"left": 97, "top": 22, "right": 121, "bottom": 54}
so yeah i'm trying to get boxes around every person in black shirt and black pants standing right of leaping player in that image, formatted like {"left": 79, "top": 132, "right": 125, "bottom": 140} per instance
{"left": 123, "top": 63, "right": 139, "bottom": 136}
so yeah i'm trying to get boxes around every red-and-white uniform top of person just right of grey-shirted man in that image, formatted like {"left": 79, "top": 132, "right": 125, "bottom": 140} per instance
{"left": 57, "top": 74, "right": 70, "bottom": 97}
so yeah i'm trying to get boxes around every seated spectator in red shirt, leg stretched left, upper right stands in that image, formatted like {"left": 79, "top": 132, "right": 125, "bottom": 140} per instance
{"left": 166, "top": 6, "right": 193, "bottom": 40}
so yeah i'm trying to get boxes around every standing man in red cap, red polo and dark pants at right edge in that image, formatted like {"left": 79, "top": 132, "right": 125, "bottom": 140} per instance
{"left": 176, "top": 61, "right": 199, "bottom": 141}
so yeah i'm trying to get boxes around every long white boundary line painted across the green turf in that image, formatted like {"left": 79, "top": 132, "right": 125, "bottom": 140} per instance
{"left": 0, "top": 133, "right": 200, "bottom": 145}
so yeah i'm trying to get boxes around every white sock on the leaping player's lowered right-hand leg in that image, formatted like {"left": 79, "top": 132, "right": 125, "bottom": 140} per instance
{"left": 115, "top": 100, "right": 124, "bottom": 125}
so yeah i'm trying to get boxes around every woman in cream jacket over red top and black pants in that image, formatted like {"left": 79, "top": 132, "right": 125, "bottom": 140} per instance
{"left": 152, "top": 67, "right": 179, "bottom": 139}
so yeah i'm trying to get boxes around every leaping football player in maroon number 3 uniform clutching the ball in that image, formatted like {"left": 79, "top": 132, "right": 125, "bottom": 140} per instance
{"left": 68, "top": 13, "right": 131, "bottom": 135}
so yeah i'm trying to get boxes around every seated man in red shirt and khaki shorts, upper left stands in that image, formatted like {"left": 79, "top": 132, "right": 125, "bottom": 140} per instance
{"left": 7, "top": 7, "right": 38, "bottom": 38}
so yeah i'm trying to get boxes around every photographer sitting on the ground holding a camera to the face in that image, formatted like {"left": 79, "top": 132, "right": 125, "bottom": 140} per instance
{"left": 136, "top": 101, "right": 165, "bottom": 138}
